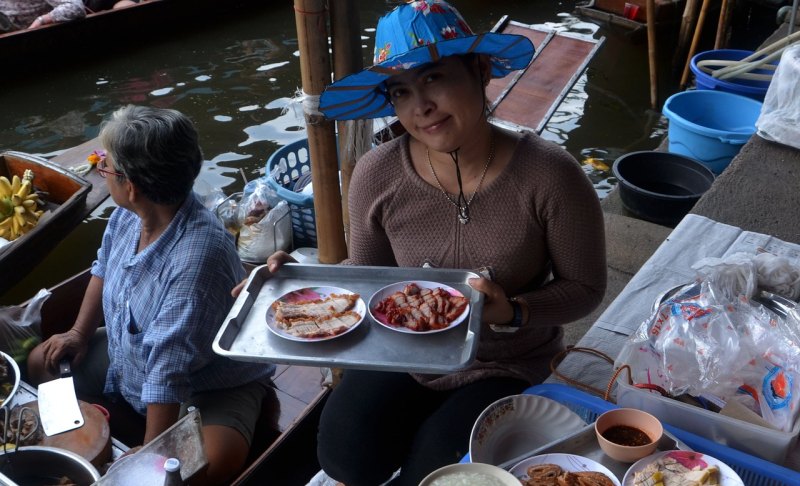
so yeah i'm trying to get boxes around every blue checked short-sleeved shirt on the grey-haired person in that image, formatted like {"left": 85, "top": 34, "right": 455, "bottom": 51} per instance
{"left": 92, "top": 194, "right": 275, "bottom": 414}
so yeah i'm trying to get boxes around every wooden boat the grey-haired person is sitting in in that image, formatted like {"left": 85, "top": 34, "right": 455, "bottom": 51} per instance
{"left": 19, "top": 269, "right": 330, "bottom": 485}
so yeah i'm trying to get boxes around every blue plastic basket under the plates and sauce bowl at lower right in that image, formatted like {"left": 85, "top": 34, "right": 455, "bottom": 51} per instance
{"left": 524, "top": 383, "right": 800, "bottom": 486}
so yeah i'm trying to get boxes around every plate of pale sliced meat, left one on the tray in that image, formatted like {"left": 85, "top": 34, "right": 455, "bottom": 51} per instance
{"left": 267, "top": 287, "right": 367, "bottom": 342}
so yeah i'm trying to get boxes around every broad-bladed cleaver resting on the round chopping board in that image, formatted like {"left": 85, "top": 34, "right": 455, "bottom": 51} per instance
{"left": 37, "top": 360, "right": 83, "bottom": 436}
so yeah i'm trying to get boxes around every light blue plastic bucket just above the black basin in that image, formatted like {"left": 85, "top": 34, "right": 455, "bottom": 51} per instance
{"left": 663, "top": 90, "right": 761, "bottom": 175}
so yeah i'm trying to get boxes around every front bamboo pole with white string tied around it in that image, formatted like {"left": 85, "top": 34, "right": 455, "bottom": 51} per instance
{"left": 294, "top": 0, "right": 347, "bottom": 263}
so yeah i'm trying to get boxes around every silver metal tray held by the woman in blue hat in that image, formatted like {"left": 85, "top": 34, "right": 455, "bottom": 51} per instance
{"left": 213, "top": 263, "right": 483, "bottom": 373}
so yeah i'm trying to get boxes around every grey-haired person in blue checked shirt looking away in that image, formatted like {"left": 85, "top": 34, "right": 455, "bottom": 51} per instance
{"left": 28, "top": 105, "right": 275, "bottom": 484}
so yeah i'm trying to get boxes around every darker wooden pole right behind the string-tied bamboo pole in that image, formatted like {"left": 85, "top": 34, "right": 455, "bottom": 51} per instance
{"left": 330, "top": 0, "right": 364, "bottom": 245}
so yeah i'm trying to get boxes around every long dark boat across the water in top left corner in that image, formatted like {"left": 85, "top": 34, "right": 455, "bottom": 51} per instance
{"left": 0, "top": 0, "right": 275, "bottom": 79}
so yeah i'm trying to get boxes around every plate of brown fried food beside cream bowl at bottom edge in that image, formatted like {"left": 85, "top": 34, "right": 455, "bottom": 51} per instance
{"left": 509, "top": 453, "right": 620, "bottom": 486}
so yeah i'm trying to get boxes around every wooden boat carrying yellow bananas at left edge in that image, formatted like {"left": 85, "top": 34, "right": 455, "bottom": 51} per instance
{"left": 0, "top": 152, "right": 93, "bottom": 293}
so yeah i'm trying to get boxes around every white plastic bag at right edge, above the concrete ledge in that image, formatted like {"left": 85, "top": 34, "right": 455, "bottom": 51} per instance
{"left": 756, "top": 43, "right": 800, "bottom": 149}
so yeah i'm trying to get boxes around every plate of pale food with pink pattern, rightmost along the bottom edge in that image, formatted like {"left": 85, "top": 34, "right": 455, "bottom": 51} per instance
{"left": 622, "top": 451, "right": 744, "bottom": 486}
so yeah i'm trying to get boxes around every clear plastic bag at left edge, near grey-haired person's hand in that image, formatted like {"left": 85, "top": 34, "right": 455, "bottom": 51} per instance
{"left": 0, "top": 289, "right": 50, "bottom": 367}
